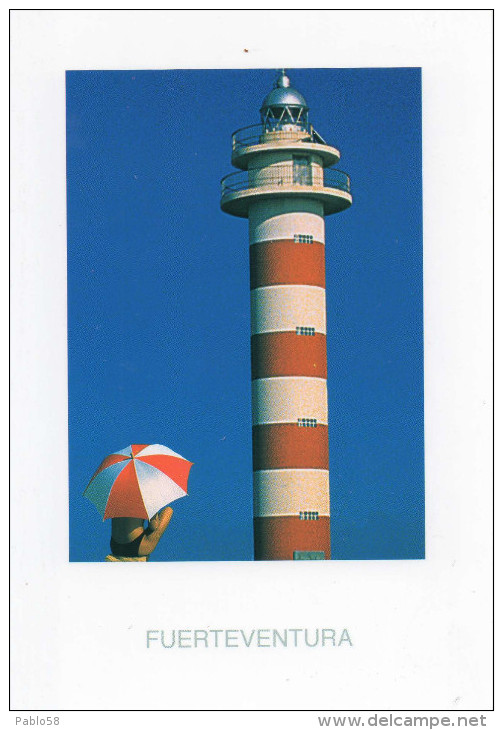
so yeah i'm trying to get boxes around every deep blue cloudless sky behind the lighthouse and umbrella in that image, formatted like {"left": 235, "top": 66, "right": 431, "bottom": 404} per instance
{"left": 67, "top": 69, "right": 424, "bottom": 561}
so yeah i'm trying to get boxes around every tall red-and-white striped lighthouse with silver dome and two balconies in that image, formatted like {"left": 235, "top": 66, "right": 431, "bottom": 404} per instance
{"left": 221, "top": 70, "right": 352, "bottom": 560}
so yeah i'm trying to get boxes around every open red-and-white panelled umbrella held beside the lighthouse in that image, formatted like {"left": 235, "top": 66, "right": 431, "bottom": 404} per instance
{"left": 84, "top": 444, "right": 192, "bottom": 520}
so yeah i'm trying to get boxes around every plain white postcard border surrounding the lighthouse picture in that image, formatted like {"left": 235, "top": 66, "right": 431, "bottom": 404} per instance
{"left": 10, "top": 5, "right": 492, "bottom": 728}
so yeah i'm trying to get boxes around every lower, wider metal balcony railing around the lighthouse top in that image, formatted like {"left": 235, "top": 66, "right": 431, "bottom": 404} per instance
{"left": 221, "top": 164, "right": 351, "bottom": 197}
